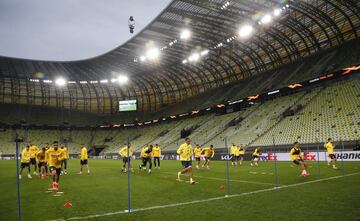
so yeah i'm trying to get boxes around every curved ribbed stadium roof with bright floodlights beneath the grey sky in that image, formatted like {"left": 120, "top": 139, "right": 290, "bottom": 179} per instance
{"left": 0, "top": 0, "right": 360, "bottom": 113}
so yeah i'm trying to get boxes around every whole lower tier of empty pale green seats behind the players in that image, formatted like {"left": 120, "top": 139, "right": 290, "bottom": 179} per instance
{"left": 0, "top": 73, "right": 360, "bottom": 154}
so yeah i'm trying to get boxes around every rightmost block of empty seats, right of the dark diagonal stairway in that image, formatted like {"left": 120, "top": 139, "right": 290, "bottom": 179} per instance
{"left": 253, "top": 77, "right": 360, "bottom": 146}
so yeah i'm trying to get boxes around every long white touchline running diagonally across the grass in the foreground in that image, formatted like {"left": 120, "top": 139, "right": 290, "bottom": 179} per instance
{"left": 49, "top": 172, "right": 360, "bottom": 221}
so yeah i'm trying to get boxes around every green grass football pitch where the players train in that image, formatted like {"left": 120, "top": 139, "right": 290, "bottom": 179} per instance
{"left": 0, "top": 159, "right": 360, "bottom": 221}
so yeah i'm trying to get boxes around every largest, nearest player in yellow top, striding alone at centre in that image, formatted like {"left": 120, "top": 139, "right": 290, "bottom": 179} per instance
{"left": 176, "top": 137, "right": 196, "bottom": 184}
